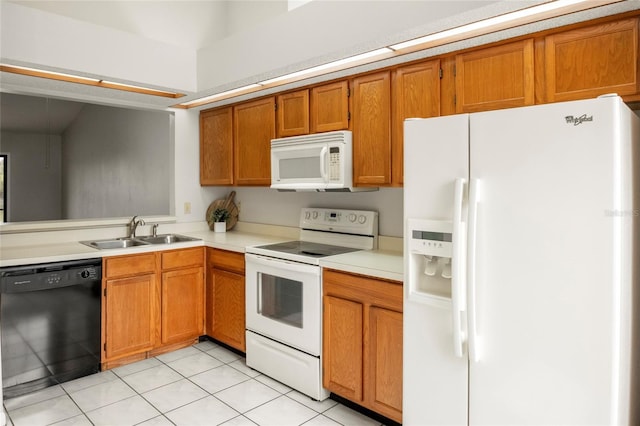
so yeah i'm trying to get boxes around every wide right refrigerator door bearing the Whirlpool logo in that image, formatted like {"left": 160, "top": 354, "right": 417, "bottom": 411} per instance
{"left": 469, "top": 98, "right": 637, "bottom": 425}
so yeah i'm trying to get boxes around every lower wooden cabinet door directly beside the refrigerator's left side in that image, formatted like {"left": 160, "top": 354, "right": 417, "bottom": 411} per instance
{"left": 365, "top": 306, "right": 402, "bottom": 423}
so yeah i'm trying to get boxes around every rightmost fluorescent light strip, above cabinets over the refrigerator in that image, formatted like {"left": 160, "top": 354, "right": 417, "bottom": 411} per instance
{"left": 389, "top": 0, "right": 620, "bottom": 53}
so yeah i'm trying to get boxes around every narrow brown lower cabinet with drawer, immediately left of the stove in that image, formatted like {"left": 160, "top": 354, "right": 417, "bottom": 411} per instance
{"left": 206, "top": 248, "right": 246, "bottom": 352}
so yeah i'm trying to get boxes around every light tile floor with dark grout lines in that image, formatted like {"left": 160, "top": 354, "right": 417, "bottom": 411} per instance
{"left": 4, "top": 341, "right": 380, "bottom": 426}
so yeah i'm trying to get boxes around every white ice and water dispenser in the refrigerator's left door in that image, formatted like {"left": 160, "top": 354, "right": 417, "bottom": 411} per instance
{"left": 406, "top": 218, "right": 459, "bottom": 301}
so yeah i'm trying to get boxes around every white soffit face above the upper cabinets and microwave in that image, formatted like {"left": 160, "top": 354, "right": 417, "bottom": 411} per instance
{"left": 197, "top": 0, "right": 498, "bottom": 90}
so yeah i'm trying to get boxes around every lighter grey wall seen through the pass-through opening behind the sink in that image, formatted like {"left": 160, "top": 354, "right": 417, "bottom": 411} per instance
{"left": 62, "top": 105, "right": 173, "bottom": 219}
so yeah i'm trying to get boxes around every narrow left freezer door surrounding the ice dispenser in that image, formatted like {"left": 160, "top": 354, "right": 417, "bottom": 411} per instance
{"left": 402, "top": 114, "right": 469, "bottom": 425}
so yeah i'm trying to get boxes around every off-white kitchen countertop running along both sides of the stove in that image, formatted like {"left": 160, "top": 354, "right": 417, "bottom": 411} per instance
{"left": 0, "top": 231, "right": 403, "bottom": 282}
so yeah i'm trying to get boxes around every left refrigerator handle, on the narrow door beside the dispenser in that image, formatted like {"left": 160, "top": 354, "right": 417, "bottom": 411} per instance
{"left": 451, "top": 178, "right": 467, "bottom": 358}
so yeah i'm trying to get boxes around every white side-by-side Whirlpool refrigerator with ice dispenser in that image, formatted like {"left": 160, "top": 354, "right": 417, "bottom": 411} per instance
{"left": 403, "top": 96, "right": 640, "bottom": 425}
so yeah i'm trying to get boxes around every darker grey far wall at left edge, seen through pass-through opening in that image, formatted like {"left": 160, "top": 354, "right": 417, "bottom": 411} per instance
{"left": 0, "top": 132, "right": 62, "bottom": 222}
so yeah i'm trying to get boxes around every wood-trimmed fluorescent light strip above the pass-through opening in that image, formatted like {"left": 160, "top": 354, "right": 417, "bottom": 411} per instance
{"left": 0, "top": 64, "right": 184, "bottom": 98}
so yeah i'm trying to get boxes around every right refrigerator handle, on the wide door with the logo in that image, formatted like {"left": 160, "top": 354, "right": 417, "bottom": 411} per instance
{"left": 467, "top": 179, "right": 480, "bottom": 362}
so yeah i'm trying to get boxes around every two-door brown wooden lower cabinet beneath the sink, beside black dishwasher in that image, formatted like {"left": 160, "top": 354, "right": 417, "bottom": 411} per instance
{"left": 101, "top": 247, "right": 204, "bottom": 369}
